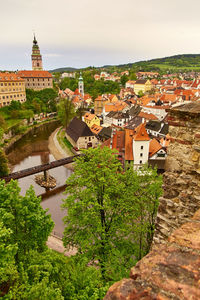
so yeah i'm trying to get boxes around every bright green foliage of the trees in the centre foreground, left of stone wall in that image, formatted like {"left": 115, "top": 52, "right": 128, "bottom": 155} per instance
{"left": 63, "top": 147, "right": 161, "bottom": 279}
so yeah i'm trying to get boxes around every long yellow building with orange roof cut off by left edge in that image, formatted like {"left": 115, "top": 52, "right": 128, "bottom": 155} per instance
{"left": 0, "top": 72, "right": 26, "bottom": 107}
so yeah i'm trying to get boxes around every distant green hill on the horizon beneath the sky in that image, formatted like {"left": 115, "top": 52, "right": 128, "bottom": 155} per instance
{"left": 50, "top": 54, "right": 200, "bottom": 72}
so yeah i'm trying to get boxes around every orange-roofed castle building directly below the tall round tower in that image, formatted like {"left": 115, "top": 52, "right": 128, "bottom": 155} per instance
{"left": 18, "top": 70, "right": 53, "bottom": 90}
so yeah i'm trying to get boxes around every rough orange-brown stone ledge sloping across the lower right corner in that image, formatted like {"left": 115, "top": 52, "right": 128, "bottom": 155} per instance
{"left": 104, "top": 210, "right": 200, "bottom": 300}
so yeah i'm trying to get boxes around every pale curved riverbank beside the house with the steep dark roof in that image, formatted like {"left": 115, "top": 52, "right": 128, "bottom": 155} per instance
{"left": 48, "top": 127, "right": 74, "bottom": 170}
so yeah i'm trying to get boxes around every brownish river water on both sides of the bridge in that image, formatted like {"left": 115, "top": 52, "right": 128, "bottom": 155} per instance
{"left": 7, "top": 124, "right": 72, "bottom": 237}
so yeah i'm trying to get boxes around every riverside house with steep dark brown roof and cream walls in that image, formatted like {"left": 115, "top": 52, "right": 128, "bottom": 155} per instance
{"left": 65, "top": 117, "right": 99, "bottom": 149}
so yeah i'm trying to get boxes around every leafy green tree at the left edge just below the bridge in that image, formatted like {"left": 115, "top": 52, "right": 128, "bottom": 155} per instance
{"left": 0, "top": 181, "right": 53, "bottom": 264}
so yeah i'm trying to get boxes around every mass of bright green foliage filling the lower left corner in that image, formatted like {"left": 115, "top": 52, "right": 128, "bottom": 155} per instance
{"left": 0, "top": 181, "right": 109, "bottom": 300}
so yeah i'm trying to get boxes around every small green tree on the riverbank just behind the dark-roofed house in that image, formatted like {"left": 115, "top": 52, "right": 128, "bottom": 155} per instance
{"left": 57, "top": 98, "right": 75, "bottom": 128}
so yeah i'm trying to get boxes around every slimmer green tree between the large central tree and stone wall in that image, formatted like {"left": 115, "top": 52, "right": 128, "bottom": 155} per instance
{"left": 124, "top": 166, "right": 162, "bottom": 259}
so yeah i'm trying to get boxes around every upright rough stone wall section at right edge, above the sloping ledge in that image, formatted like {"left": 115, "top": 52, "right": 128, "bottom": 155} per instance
{"left": 154, "top": 102, "right": 200, "bottom": 243}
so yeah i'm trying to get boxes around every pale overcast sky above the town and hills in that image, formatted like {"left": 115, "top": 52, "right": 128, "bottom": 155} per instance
{"left": 0, "top": 0, "right": 200, "bottom": 70}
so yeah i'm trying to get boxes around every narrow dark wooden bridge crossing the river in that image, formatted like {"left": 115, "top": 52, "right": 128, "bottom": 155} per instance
{"left": 0, "top": 154, "right": 83, "bottom": 182}
